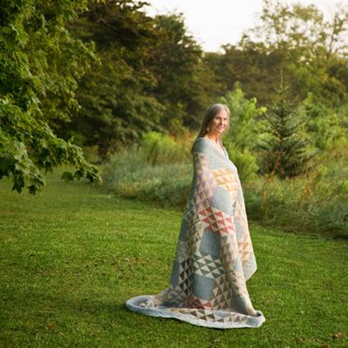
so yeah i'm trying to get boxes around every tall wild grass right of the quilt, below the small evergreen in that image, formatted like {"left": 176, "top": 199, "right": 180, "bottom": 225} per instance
{"left": 244, "top": 165, "right": 348, "bottom": 239}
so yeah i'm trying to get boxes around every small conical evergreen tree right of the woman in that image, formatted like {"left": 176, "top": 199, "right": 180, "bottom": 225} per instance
{"left": 259, "top": 86, "right": 314, "bottom": 179}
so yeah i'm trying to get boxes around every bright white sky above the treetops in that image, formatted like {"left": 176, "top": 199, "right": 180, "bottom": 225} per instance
{"left": 146, "top": 0, "right": 347, "bottom": 51}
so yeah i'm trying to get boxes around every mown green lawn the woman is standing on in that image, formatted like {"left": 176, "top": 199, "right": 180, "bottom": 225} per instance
{"left": 0, "top": 170, "right": 348, "bottom": 348}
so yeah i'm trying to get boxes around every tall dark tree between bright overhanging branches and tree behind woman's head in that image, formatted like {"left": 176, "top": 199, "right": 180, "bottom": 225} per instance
{"left": 64, "top": 0, "right": 164, "bottom": 158}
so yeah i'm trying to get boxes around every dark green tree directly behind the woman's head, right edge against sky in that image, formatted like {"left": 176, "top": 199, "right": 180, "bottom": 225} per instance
{"left": 151, "top": 14, "right": 216, "bottom": 132}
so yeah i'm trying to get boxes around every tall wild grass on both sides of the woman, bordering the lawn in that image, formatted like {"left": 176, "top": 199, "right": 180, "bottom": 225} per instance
{"left": 104, "top": 134, "right": 348, "bottom": 238}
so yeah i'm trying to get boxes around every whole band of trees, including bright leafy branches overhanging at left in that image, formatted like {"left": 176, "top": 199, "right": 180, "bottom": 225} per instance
{"left": 0, "top": 0, "right": 348, "bottom": 192}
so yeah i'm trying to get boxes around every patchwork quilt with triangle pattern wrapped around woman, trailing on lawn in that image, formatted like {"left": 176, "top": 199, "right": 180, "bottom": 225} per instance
{"left": 126, "top": 138, "right": 265, "bottom": 329}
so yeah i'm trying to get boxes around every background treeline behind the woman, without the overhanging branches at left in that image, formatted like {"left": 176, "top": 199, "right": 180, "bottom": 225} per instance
{"left": 57, "top": 0, "right": 348, "bottom": 156}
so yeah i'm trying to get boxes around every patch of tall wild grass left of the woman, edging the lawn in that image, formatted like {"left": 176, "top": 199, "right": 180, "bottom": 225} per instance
{"left": 104, "top": 132, "right": 192, "bottom": 206}
